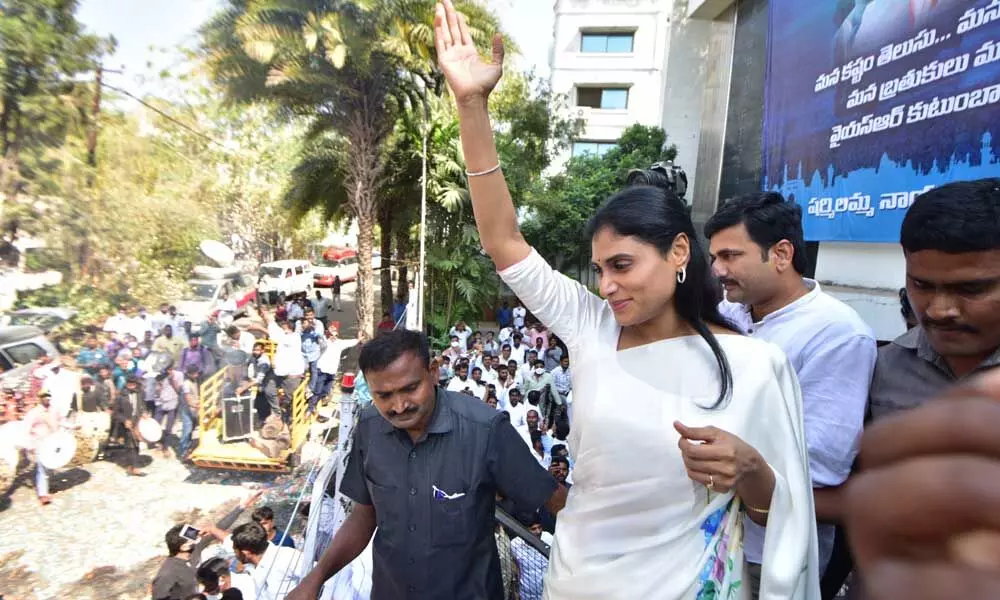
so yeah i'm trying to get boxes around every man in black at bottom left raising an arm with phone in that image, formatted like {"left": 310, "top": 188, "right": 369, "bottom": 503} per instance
{"left": 152, "top": 491, "right": 264, "bottom": 600}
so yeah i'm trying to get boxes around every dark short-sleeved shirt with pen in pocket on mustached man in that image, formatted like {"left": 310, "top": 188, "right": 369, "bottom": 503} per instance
{"left": 340, "top": 388, "right": 556, "bottom": 600}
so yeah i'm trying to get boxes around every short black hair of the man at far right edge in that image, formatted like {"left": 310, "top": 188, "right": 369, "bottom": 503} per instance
{"left": 899, "top": 178, "right": 1000, "bottom": 254}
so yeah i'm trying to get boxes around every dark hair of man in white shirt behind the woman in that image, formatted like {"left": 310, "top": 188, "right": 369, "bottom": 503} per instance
{"left": 705, "top": 192, "right": 808, "bottom": 275}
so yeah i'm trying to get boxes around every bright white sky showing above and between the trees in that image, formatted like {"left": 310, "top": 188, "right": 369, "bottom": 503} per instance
{"left": 77, "top": 0, "right": 554, "bottom": 96}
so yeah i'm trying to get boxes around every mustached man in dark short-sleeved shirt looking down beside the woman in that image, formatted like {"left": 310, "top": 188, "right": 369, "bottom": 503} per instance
{"left": 288, "top": 330, "right": 566, "bottom": 600}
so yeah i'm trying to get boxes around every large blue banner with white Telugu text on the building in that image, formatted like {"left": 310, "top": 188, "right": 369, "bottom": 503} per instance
{"left": 763, "top": 0, "right": 1000, "bottom": 242}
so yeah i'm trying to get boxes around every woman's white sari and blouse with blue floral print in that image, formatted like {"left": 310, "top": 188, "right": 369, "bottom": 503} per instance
{"left": 500, "top": 251, "right": 820, "bottom": 600}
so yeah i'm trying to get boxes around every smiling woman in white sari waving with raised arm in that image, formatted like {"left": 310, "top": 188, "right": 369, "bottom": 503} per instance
{"left": 435, "top": 0, "right": 819, "bottom": 600}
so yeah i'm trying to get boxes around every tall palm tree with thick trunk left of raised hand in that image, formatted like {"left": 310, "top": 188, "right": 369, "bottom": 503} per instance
{"left": 205, "top": 0, "right": 496, "bottom": 339}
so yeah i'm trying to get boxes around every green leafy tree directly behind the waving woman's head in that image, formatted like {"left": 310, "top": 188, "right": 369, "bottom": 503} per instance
{"left": 521, "top": 124, "right": 677, "bottom": 270}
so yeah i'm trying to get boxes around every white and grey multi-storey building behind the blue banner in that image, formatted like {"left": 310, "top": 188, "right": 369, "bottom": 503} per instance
{"left": 550, "top": 0, "right": 905, "bottom": 340}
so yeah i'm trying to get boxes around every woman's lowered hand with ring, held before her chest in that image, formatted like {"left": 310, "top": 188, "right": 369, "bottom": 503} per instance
{"left": 674, "top": 421, "right": 764, "bottom": 494}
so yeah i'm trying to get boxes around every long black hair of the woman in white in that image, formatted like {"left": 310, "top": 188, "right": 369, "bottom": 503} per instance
{"left": 587, "top": 176, "right": 735, "bottom": 408}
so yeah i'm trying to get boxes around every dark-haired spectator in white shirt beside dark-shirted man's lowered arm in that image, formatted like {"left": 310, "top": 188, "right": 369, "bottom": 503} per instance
{"left": 233, "top": 523, "right": 302, "bottom": 600}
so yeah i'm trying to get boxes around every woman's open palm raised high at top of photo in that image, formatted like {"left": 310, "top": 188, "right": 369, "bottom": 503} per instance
{"left": 434, "top": 0, "right": 504, "bottom": 103}
